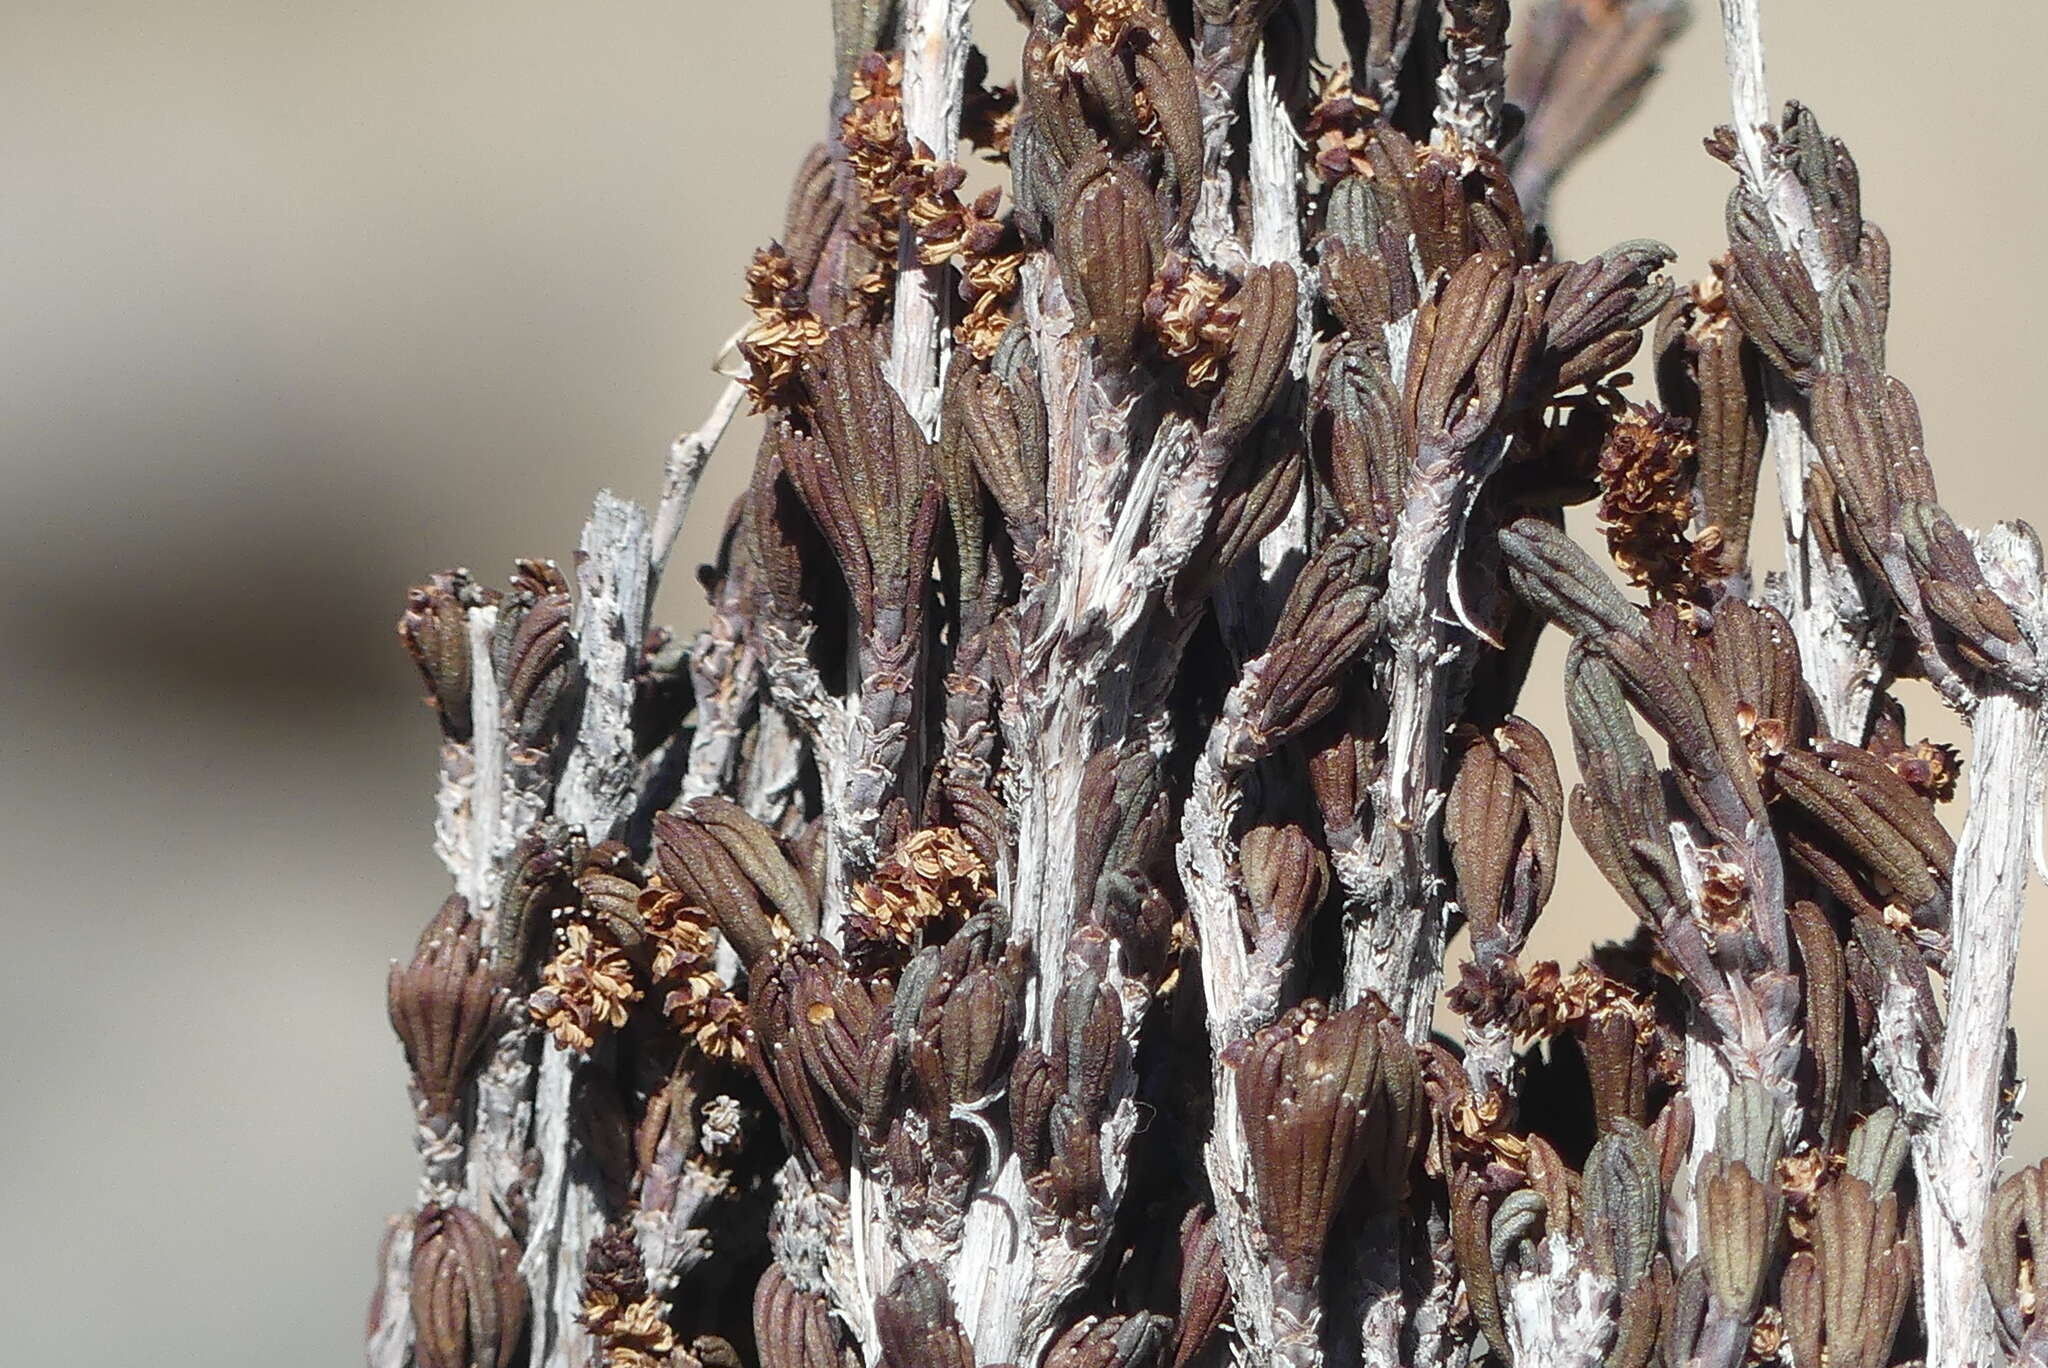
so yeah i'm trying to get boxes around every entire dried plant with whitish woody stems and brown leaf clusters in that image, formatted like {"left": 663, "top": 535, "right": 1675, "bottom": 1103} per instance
{"left": 371, "top": 0, "right": 2048, "bottom": 1368}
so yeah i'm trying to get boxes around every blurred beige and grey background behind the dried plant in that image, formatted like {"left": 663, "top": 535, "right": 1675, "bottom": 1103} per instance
{"left": 0, "top": 0, "right": 2048, "bottom": 1368}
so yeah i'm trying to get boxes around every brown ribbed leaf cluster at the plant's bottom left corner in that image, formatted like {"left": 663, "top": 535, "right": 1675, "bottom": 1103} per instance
{"left": 412, "top": 1206, "right": 526, "bottom": 1368}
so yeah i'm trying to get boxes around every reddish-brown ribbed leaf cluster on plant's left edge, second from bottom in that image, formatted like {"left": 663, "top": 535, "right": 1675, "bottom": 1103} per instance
{"left": 387, "top": 893, "right": 506, "bottom": 1120}
